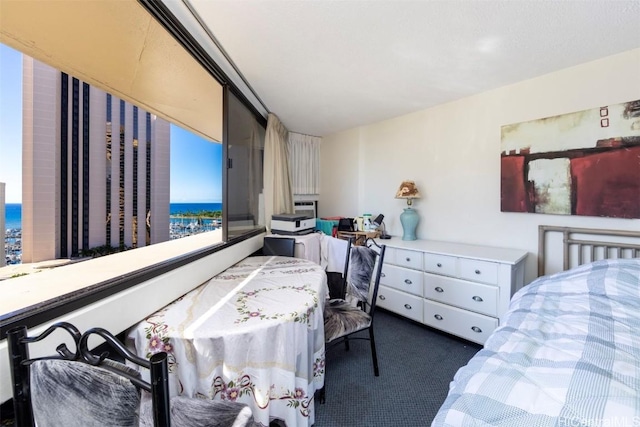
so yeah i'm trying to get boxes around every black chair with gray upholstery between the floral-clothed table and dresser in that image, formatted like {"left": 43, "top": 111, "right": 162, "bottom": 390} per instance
{"left": 324, "top": 238, "right": 386, "bottom": 376}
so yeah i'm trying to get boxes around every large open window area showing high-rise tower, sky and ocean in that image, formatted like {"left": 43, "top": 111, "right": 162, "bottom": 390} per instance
{"left": 0, "top": 45, "right": 230, "bottom": 264}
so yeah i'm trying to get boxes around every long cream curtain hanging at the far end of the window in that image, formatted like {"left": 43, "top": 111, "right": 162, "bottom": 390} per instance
{"left": 264, "top": 113, "right": 294, "bottom": 230}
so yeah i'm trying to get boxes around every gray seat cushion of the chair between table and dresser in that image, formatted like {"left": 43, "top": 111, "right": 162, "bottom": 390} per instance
{"left": 324, "top": 300, "right": 371, "bottom": 342}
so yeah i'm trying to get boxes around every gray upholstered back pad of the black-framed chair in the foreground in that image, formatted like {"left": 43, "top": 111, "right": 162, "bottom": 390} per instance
{"left": 31, "top": 360, "right": 140, "bottom": 427}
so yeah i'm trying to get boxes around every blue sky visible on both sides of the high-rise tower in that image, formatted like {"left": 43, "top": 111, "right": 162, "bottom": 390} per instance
{"left": 0, "top": 43, "right": 222, "bottom": 203}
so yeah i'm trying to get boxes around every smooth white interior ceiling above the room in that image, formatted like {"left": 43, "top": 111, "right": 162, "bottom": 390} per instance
{"left": 171, "top": 0, "right": 640, "bottom": 136}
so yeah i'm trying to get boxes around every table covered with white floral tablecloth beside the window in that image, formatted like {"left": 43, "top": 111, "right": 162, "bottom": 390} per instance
{"left": 127, "top": 256, "right": 328, "bottom": 427}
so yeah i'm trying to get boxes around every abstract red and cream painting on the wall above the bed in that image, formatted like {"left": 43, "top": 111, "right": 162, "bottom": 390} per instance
{"left": 500, "top": 100, "right": 640, "bottom": 218}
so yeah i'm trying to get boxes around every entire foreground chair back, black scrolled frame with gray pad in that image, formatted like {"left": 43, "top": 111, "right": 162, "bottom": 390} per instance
{"left": 7, "top": 322, "right": 170, "bottom": 427}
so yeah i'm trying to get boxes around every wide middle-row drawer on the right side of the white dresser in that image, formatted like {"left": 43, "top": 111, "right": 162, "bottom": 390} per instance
{"left": 424, "top": 273, "right": 499, "bottom": 317}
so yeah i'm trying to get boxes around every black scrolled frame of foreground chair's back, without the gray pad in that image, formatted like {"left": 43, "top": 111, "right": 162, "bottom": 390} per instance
{"left": 7, "top": 322, "right": 171, "bottom": 427}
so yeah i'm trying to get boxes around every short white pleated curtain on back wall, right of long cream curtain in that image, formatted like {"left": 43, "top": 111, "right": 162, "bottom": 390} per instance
{"left": 289, "top": 132, "right": 322, "bottom": 194}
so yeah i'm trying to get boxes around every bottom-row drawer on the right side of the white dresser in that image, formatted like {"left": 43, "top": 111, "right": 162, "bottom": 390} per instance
{"left": 424, "top": 300, "right": 498, "bottom": 344}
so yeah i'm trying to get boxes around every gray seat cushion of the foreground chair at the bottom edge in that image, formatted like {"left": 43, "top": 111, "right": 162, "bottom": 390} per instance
{"left": 140, "top": 396, "right": 256, "bottom": 427}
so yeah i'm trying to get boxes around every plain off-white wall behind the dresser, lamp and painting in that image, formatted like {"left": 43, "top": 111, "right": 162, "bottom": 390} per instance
{"left": 318, "top": 49, "right": 640, "bottom": 283}
